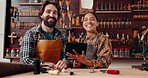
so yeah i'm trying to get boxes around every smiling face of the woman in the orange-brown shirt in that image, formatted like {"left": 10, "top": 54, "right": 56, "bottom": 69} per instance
{"left": 83, "top": 13, "right": 98, "bottom": 32}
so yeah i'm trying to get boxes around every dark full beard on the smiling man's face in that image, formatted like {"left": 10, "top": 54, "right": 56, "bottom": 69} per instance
{"left": 43, "top": 17, "right": 57, "bottom": 28}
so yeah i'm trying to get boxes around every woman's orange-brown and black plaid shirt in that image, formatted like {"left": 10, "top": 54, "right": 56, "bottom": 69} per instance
{"left": 80, "top": 32, "right": 113, "bottom": 68}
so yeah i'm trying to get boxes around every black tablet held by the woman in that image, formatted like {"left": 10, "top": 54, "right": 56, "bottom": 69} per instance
{"left": 65, "top": 42, "right": 87, "bottom": 54}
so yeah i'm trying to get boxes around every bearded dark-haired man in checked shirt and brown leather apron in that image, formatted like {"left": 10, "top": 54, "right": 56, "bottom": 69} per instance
{"left": 20, "top": 1, "right": 67, "bottom": 69}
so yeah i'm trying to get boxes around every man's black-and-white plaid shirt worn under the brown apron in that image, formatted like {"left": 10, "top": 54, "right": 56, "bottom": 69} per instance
{"left": 20, "top": 26, "right": 67, "bottom": 64}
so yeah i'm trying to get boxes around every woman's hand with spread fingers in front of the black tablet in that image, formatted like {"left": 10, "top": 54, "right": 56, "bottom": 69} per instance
{"left": 66, "top": 50, "right": 87, "bottom": 64}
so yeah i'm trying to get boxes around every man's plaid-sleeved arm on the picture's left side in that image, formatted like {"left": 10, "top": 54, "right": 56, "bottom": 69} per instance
{"left": 20, "top": 31, "right": 36, "bottom": 64}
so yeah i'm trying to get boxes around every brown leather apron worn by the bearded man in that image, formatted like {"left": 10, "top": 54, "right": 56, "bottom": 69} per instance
{"left": 36, "top": 35, "right": 63, "bottom": 64}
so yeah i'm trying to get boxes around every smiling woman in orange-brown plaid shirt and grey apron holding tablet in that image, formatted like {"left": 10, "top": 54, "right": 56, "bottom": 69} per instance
{"left": 66, "top": 13, "right": 112, "bottom": 68}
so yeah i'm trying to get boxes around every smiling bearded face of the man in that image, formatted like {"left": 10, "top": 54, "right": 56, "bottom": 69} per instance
{"left": 41, "top": 4, "right": 58, "bottom": 28}
